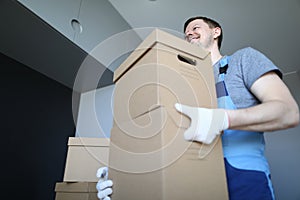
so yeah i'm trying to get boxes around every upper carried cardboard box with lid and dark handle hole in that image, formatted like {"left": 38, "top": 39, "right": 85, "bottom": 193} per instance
{"left": 114, "top": 30, "right": 213, "bottom": 123}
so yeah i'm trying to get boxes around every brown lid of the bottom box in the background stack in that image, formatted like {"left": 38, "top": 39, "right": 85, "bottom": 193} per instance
{"left": 55, "top": 182, "right": 97, "bottom": 192}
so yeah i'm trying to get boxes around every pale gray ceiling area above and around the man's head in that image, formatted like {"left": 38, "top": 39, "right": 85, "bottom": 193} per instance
{"left": 109, "top": 0, "right": 300, "bottom": 73}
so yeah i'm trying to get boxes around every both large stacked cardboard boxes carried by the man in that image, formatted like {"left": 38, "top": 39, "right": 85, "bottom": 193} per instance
{"left": 109, "top": 30, "right": 228, "bottom": 200}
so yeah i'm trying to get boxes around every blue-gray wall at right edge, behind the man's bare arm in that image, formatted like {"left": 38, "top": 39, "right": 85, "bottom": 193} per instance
{"left": 265, "top": 73, "right": 300, "bottom": 200}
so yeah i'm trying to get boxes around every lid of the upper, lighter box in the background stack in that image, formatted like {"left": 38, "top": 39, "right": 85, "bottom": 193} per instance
{"left": 68, "top": 137, "right": 110, "bottom": 147}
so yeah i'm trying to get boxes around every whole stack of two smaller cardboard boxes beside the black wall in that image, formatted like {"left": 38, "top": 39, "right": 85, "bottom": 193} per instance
{"left": 55, "top": 137, "right": 109, "bottom": 200}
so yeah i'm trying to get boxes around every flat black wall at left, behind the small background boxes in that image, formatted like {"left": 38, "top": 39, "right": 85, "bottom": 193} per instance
{"left": 0, "top": 53, "right": 75, "bottom": 200}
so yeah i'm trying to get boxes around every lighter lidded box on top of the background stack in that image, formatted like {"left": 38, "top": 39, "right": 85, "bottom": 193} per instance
{"left": 63, "top": 137, "right": 110, "bottom": 182}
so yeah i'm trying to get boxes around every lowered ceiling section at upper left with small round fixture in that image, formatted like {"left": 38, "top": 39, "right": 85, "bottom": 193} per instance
{"left": 0, "top": 0, "right": 131, "bottom": 92}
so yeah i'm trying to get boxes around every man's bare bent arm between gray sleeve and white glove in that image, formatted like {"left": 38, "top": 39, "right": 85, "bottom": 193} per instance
{"left": 226, "top": 72, "right": 299, "bottom": 132}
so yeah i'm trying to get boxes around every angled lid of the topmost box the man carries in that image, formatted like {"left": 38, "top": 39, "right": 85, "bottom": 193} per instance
{"left": 113, "top": 29, "right": 210, "bottom": 82}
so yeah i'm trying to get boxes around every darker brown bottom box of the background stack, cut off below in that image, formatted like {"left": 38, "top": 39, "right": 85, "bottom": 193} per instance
{"left": 55, "top": 182, "right": 99, "bottom": 200}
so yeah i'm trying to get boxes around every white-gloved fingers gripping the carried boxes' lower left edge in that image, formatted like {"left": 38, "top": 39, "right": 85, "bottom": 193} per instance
{"left": 96, "top": 167, "right": 113, "bottom": 200}
